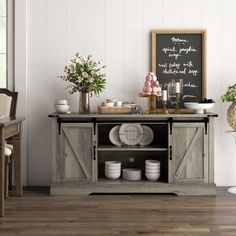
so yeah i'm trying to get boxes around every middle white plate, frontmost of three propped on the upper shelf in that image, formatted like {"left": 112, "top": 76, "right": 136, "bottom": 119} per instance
{"left": 119, "top": 123, "right": 143, "bottom": 146}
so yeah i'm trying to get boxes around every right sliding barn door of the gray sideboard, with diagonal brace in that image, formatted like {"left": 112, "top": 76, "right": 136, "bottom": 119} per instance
{"left": 169, "top": 123, "right": 208, "bottom": 182}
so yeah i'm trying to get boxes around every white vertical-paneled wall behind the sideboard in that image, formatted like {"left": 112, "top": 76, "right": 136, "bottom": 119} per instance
{"left": 16, "top": 0, "right": 236, "bottom": 185}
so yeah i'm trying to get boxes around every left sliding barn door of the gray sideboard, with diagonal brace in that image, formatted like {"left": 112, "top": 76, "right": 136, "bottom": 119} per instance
{"left": 60, "top": 123, "right": 93, "bottom": 182}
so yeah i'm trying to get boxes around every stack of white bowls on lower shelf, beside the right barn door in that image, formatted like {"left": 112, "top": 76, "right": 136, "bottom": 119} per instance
{"left": 145, "top": 160, "right": 161, "bottom": 181}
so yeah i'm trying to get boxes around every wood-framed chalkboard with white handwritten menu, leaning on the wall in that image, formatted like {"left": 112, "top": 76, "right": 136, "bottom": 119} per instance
{"left": 152, "top": 30, "right": 206, "bottom": 108}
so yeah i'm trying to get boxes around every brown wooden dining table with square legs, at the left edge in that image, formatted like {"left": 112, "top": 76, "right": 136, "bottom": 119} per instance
{"left": 0, "top": 117, "right": 25, "bottom": 217}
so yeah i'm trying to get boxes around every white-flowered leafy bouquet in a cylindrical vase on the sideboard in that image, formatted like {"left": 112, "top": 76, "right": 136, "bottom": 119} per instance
{"left": 58, "top": 53, "right": 106, "bottom": 113}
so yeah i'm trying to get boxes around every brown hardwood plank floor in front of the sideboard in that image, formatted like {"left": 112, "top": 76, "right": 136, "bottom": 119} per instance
{"left": 0, "top": 188, "right": 236, "bottom": 236}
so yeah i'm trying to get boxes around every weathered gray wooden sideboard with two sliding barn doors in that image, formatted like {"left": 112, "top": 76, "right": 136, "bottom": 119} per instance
{"left": 49, "top": 113, "right": 217, "bottom": 195}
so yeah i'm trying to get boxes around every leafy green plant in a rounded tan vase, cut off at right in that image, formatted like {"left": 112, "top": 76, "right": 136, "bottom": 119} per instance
{"left": 221, "top": 83, "right": 236, "bottom": 130}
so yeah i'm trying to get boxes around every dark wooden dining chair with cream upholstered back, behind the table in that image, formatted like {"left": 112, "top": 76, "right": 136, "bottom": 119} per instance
{"left": 0, "top": 88, "right": 18, "bottom": 197}
